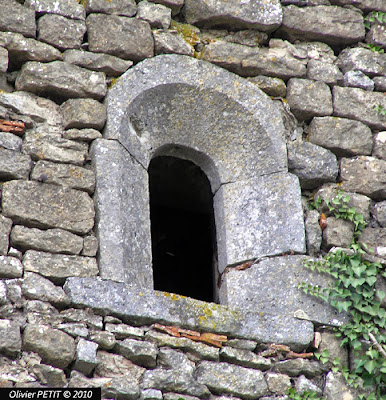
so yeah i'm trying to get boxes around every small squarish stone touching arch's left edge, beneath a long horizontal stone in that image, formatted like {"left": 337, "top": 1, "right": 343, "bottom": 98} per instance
{"left": 60, "top": 99, "right": 106, "bottom": 130}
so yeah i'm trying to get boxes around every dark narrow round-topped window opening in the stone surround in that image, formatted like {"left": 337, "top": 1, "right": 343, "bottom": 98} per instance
{"left": 149, "top": 156, "right": 217, "bottom": 301}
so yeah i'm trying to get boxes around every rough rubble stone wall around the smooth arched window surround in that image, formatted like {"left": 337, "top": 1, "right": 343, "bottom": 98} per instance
{"left": 0, "top": 0, "right": 386, "bottom": 400}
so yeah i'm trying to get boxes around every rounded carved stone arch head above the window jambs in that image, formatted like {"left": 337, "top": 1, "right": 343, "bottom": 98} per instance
{"left": 104, "top": 55, "right": 287, "bottom": 190}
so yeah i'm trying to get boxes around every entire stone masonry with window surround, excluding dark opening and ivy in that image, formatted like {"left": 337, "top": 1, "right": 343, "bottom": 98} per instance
{"left": 0, "top": 0, "right": 386, "bottom": 400}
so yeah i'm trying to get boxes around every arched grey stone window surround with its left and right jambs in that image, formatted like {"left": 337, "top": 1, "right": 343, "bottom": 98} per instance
{"left": 92, "top": 55, "right": 305, "bottom": 296}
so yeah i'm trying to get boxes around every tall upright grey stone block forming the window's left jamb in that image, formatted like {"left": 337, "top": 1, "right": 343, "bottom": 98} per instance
{"left": 91, "top": 139, "right": 153, "bottom": 288}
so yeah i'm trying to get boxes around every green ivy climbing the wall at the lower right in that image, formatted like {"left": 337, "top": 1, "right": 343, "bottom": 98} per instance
{"left": 300, "top": 191, "right": 386, "bottom": 400}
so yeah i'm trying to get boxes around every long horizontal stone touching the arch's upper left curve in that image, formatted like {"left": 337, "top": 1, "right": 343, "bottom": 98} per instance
{"left": 16, "top": 61, "right": 107, "bottom": 99}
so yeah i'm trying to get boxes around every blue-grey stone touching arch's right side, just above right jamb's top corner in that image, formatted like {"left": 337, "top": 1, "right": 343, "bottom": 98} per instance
{"left": 288, "top": 141, "right": 338, "bottom": 189}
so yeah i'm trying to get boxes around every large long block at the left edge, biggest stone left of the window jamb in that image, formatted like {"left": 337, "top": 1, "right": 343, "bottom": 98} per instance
{"left": 2, "top": 181, "right": 94, "bottom": 234}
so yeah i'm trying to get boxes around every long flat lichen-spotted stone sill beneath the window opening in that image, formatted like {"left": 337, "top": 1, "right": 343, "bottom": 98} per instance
{"left": 64, "top": 277, "right": 314, "bottom": 350}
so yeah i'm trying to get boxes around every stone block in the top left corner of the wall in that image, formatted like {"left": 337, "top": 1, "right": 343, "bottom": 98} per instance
{"left": 0, "top": 0, "right": 36, "bottom": 37}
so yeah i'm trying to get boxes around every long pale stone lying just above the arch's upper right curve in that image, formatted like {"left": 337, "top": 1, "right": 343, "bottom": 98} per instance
{"left": 201, "top": 40, "right": 307, "bottom": 80}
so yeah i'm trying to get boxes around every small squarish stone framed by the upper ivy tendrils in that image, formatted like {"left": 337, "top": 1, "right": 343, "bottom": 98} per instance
{"left": 323, "top": 217, "right": 354, "bottom": 249}
